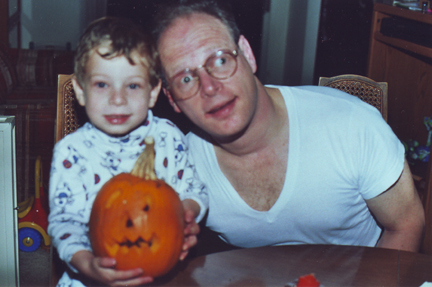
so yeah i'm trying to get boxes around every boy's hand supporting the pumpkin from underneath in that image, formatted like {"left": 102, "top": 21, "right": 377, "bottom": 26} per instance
{"left": 71, "top": 250, "right": 153, "bottom": 286}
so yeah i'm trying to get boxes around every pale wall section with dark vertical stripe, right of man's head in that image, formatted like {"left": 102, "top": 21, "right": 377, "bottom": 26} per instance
{"left": 258, "top": 0, "right": 321, "bottom": 85}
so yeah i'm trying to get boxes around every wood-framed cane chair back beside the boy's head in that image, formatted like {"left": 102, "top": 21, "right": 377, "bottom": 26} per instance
{"left": 55, "top": 74, "right": 87, "bottom": 142}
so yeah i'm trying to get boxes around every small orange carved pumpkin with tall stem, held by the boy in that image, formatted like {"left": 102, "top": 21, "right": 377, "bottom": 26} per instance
{"left": 89, "top": 138, "right": 183, "bottom": 277}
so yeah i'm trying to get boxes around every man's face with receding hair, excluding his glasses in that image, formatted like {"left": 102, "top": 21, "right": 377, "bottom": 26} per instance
{"left": 158, "top": 14, "right": 257, "bottom": 139}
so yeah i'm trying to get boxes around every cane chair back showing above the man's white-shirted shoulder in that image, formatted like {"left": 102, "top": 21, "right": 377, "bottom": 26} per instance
{"left": 318, "top": 74, "right": 387, "bottom": 121}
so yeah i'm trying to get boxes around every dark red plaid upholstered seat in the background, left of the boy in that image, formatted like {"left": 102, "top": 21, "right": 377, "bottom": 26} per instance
{"left": 0, "top": 42, "right": 73, "bottom": 202}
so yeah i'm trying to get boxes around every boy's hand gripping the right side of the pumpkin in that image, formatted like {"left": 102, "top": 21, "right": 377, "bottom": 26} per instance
{"left": 180, "top": 199, "right": 200, "bottom": 260}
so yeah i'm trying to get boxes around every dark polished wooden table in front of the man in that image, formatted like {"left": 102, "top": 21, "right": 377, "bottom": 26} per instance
{"left": 154, "top": 245, "right": 432, "bottom": 287}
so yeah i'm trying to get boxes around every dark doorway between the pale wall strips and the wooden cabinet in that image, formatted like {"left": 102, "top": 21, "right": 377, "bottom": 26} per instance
{"left": 314, "top": 0, "right": 373, "bottom": 84}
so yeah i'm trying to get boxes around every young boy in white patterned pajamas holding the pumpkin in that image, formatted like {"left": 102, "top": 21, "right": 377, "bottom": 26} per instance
{"left": 48, "top": 17, "right": 207, "bottom": 286}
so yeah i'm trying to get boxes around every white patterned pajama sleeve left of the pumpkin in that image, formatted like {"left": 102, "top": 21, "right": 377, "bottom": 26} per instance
{"left": 48, "top": 146, "right": 91, "bottom": 272}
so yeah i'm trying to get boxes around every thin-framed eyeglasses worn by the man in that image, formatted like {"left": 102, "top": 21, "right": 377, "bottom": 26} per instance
{"left": 163, "top": 49, "right": 239, "bottom": 101}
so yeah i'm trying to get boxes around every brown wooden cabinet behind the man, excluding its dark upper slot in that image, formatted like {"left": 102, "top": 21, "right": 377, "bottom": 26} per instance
{"left": 367, "top": 3, "right": 432, "bottom": 144}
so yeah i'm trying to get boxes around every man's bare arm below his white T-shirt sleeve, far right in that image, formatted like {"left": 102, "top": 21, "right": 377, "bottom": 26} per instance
{"left": 366, "top": 161, "right": 425, "bottom": 252}
